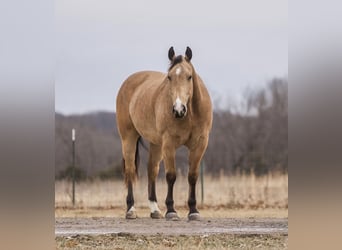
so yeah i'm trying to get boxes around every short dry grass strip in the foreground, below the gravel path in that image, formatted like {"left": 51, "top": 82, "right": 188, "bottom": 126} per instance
{"left": 56, "top": 234, "right": 288, "bottom": 250}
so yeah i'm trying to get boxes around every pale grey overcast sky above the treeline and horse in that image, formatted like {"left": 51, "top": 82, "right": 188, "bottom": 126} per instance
{"left": 55, "top": 0, "right": 288, "bottom": 114}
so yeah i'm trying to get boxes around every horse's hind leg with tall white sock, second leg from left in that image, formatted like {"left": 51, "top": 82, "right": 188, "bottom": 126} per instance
{"left": 148, "top": 143, "right": 163, "bottom": 219}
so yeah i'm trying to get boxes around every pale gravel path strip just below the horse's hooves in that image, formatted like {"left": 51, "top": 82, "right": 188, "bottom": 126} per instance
{"left": 55, "top": 217, "right": 288, "bottom": 237}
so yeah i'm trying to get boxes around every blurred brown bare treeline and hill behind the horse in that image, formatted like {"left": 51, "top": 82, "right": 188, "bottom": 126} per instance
{"left": 55, "top": 78, "right": 288, "bottom": 179}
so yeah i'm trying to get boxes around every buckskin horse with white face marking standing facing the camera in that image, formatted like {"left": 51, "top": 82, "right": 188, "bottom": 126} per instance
{"left": 116, "top": 47, "right": 212, "bottom": 220}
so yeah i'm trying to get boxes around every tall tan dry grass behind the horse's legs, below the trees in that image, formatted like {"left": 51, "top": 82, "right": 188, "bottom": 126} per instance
{"left": 55, "top": 175, "right": 288, "bottom": 213}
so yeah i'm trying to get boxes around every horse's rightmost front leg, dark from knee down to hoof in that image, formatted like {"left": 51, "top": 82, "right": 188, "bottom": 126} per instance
{"left": 188, "top": 138, "right": 208, "bottom": 220}
